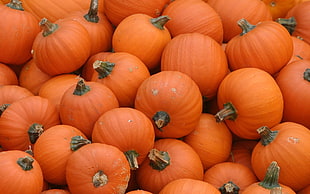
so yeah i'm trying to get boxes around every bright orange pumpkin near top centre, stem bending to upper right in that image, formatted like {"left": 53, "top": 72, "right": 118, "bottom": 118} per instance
{"left": 112, "top": 13, "right": 171, "bottom": 69}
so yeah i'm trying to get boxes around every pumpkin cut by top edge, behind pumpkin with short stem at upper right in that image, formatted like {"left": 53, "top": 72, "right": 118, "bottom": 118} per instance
{"left": 207, "top": 0, "right": 272, "bottom": 43}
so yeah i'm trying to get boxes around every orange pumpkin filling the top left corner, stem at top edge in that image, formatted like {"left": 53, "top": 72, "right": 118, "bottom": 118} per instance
{"left": 0, "top": 1, "right": 40, "bottom": 65}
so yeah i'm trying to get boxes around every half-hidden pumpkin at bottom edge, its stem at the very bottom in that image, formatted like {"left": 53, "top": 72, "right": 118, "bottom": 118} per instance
{"left": 203, "top": 162, "right": 258, "bottom": 193}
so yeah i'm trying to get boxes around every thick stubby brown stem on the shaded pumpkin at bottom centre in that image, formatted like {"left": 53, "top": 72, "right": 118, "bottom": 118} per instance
{"left": 148, "top": 149, "right": 170, "bottom": 171}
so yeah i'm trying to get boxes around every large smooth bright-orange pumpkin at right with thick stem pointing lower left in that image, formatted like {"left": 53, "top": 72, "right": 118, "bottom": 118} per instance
{"left": 215, "top": 67, "right": 284, "bottom": 139}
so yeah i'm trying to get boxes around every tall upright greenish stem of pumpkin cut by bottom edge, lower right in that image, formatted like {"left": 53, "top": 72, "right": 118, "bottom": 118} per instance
{"left": 258, "top": 161, "right": 280, "bottom": 189}
